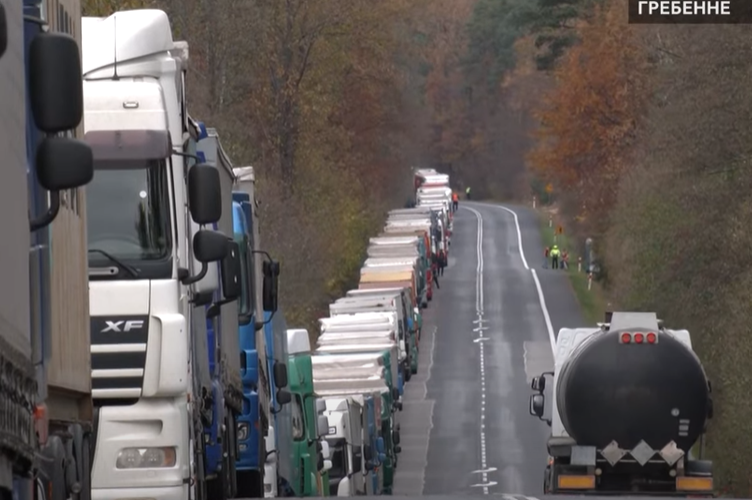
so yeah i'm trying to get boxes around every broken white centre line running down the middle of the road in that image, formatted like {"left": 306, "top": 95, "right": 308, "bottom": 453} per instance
{"left": 463, "top": 206, "right": 490, "bottom": 495}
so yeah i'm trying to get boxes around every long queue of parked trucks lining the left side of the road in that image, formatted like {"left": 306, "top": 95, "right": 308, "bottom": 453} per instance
{"left": 0, "top": 0, "right": 452, "bottom": 500}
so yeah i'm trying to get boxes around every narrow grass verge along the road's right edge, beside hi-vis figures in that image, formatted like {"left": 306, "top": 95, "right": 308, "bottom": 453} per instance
{"left": 538, "top": 209, "right": 607, "bottom": 323}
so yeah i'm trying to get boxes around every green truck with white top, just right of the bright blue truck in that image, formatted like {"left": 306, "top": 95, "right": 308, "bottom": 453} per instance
{"left": 287, "top": 328, "right": 332, "bottom": 497}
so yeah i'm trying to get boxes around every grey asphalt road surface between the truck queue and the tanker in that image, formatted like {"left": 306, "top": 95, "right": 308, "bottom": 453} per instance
{"left": 394, "top": 202, "right": 585, "bottom": 496}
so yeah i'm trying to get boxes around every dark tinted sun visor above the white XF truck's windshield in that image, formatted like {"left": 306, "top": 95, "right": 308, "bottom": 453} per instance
{"left": 84, "top": 130, "right": 172, "bottom": 162}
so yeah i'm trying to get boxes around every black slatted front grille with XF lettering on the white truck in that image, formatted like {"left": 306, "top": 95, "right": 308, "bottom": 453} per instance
{"left": 91, "top": 316, "right": 149, "bottom": 400}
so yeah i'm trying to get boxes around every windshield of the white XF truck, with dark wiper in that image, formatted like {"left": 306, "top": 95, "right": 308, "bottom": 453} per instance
{"left": 86, "top": 160, "right": 172, "bottom": 277}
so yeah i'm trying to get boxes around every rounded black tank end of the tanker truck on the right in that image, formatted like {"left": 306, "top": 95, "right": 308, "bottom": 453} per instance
{"left": 555, "top": 315, "right": 711, "bottom": 452}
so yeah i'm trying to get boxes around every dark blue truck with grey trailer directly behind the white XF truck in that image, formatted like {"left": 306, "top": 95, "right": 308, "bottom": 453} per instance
{"left": 196, "top": 124, "right": 242, "bottom": 498}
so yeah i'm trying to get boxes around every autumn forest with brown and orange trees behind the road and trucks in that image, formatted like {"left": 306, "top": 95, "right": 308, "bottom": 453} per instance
{"left": 83, "top": 0, "right": 752, "bottom": 497}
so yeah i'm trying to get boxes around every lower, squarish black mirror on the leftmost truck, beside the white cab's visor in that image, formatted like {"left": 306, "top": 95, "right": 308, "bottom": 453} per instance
{"left": 36, "top": 137, "right": 94, "bottom": 192}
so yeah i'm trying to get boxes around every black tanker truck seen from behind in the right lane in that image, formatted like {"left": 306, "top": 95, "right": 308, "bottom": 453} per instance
{"left": 530, "top": 312, "right": 714, "bottom": 497}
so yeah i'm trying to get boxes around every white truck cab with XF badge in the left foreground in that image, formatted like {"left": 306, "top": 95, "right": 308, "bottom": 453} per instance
{"left": 82, "top": 10, "right": 234, "bottom": 500}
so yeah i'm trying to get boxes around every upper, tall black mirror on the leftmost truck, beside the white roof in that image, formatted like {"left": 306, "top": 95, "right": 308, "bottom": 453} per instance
{"left": 29, "top": 33, "right": 84, "bottom": 134}
